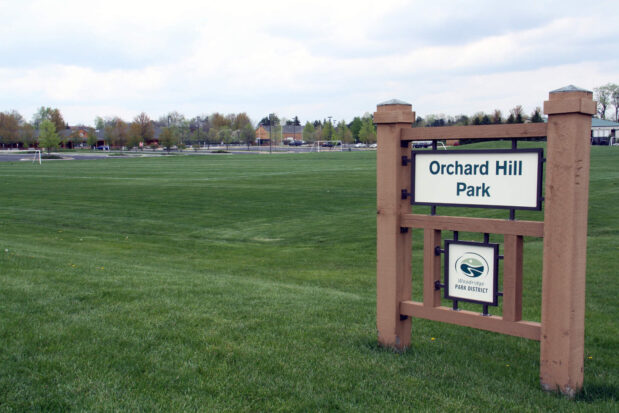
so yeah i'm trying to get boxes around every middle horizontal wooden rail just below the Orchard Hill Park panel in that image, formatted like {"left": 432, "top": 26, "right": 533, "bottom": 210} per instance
{"left": 400, "top": 214, "right": 544, "bottom": 238}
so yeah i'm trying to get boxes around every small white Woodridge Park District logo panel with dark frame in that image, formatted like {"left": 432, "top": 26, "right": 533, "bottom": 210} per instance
{"left": 445, "top": 241, "right": 499, "bottom": 305}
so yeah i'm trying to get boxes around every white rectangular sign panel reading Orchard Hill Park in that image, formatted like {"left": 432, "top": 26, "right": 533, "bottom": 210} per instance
{"left": 411, "top": 149, "right": 543, "bottom": 211}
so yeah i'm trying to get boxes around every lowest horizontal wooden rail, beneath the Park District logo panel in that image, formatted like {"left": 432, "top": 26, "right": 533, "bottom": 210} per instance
{"left": 400, "top": 301, "right": 541, "bottom": 341}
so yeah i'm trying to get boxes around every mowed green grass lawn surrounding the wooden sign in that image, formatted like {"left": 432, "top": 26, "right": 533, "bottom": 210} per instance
{"left": 0, "top": 147, "right": 619, "bottom": 412}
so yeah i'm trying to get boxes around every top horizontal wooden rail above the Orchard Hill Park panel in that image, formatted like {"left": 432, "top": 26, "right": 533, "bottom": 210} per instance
{"left": 400, "top": 123, "right": 546, "bottom": 141}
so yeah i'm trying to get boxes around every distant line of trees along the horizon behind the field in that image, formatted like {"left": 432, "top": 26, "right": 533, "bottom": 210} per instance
{"left": 0, "top": 87, "right": 619, "bottom": 150}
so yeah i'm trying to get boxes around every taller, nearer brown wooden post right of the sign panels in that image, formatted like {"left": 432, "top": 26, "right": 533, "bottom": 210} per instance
{"left": 540, "top": 88, "right": 596, "bottom": 396}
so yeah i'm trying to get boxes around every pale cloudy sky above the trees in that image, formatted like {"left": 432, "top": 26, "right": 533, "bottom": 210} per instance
{"left": 0, "top": 0, "right": 619, "bottom": 125}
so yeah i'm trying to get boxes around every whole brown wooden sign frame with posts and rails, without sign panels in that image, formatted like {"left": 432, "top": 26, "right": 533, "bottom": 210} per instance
{"left": 374, "top": 86, "right": 596, "bottom": 396}
